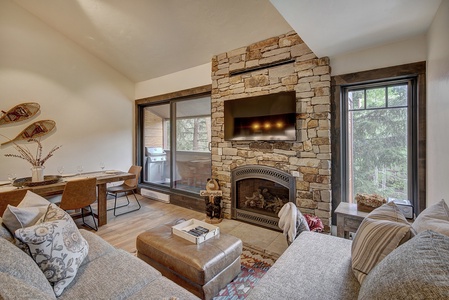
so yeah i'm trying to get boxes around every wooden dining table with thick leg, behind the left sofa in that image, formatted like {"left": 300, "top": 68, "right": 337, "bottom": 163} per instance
{"left": 17, "top": 172, "right": 136, "bottom": 226}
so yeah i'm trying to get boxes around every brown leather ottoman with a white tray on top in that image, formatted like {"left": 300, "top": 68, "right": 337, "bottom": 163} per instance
{"left": 136, "top": 224, "right": 242, "bottom": 299}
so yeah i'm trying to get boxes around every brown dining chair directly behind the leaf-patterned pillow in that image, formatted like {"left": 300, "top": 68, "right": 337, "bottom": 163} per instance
{"left": 59, "top": 178, "right": 98, "bottom": 231}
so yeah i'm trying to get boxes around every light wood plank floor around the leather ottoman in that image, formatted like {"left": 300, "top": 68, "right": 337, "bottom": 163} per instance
{"left": 76, "top": 195, "right": 287, "bottom": 257}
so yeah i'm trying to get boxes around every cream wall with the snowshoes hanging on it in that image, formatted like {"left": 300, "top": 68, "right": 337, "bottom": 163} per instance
{"left": 0, "top": 1, "right": 134, "bottom": 180}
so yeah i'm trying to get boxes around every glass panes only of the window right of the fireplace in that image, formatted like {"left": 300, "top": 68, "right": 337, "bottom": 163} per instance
{"left": 344, "top": 80, "right": 415, "bottom": 202}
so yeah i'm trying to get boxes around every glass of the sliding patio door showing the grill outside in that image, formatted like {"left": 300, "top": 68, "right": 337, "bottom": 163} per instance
{"left": 140, "top": 96, "right": 211, "bottom": 194}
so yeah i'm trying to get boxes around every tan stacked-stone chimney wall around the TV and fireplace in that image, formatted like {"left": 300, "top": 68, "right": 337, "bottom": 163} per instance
{"left": 208, "top": 32, "right": 332, "bottom": 229}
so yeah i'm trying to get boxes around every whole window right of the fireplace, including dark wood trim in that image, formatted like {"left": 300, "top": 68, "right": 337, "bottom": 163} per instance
{"left": 331, "top": 62, "right": 426, "bottom": 223}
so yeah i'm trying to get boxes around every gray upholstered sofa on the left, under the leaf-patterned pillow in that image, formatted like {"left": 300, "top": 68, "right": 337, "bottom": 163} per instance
{"left": 0, "top": 225, "right": 198, "bottom": 299}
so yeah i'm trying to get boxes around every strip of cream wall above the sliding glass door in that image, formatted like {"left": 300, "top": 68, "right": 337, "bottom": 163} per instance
{"left": 135, "top": 62, "right": 212, "bottom": 99}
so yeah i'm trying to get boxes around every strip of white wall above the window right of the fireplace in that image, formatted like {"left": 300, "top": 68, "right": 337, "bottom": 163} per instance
{"left": 330, "top": 35, "right": 427, "bottom": 76}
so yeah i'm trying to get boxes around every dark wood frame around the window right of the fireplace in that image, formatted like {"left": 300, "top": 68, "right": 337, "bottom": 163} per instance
{"left": 331, "top": 62, "right": 426, "bottom": 224}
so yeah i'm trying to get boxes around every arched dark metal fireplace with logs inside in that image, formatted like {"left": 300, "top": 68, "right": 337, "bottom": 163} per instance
{"left": 231, "top": 165, "right": 296, "bottom": 230}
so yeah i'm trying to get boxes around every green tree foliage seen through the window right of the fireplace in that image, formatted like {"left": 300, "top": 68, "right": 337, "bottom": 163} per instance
{"left": 348, "top": 85, "right": 408, "bottom": 199}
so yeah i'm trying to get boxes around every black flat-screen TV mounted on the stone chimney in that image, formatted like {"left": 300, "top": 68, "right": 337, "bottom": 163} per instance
{"left": 224, "top": 91, "right": 296, "bottom": 141}
